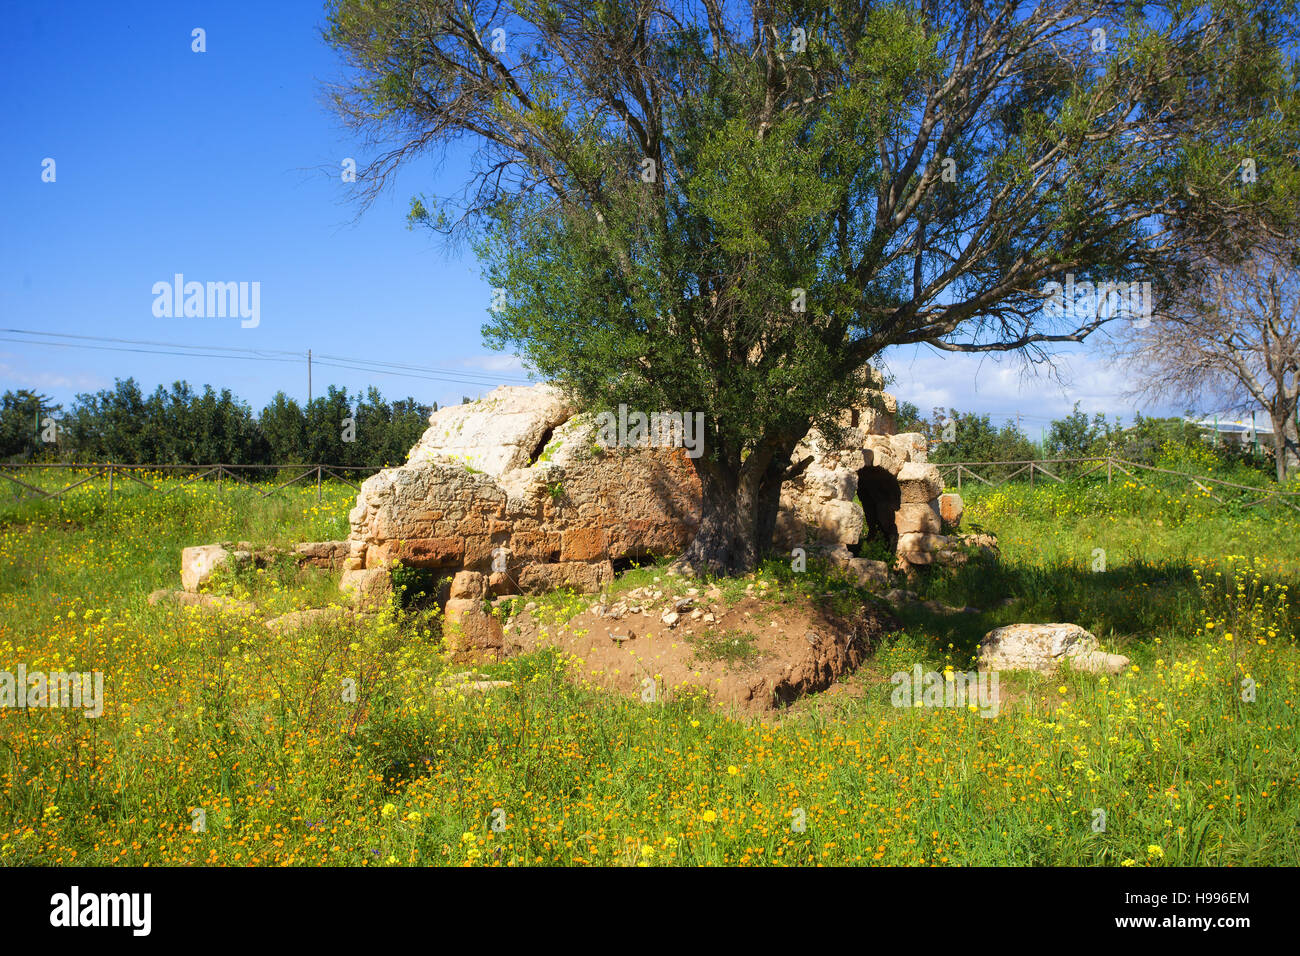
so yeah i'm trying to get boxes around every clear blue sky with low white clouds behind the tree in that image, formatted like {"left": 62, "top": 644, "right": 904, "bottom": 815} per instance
{"left": 0, "top": 0, "right": 1175, "bottom": 437}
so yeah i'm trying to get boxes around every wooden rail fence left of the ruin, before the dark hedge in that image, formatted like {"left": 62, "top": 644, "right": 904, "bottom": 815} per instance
{"left": 0, "top": 462, "right": 386, "bottom": 501}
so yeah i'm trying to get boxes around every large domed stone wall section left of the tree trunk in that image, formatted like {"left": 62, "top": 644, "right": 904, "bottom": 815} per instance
{"left": 343, "top": 385, "right": 699, "bottom": 593}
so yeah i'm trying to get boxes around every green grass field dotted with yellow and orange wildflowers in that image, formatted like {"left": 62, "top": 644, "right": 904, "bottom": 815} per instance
{"left": 0, "top": 470, "right": 1300, "bottom": 866}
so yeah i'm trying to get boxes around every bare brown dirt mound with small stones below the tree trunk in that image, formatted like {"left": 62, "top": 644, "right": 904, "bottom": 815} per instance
{"left": 504, "top": 588, "right": 898, "bottom": 714}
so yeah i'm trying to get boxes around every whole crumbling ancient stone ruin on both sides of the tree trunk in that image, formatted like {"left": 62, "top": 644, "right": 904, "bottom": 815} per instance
{"left": 341, "top": 385, "right": 965, "bottom": 629}
